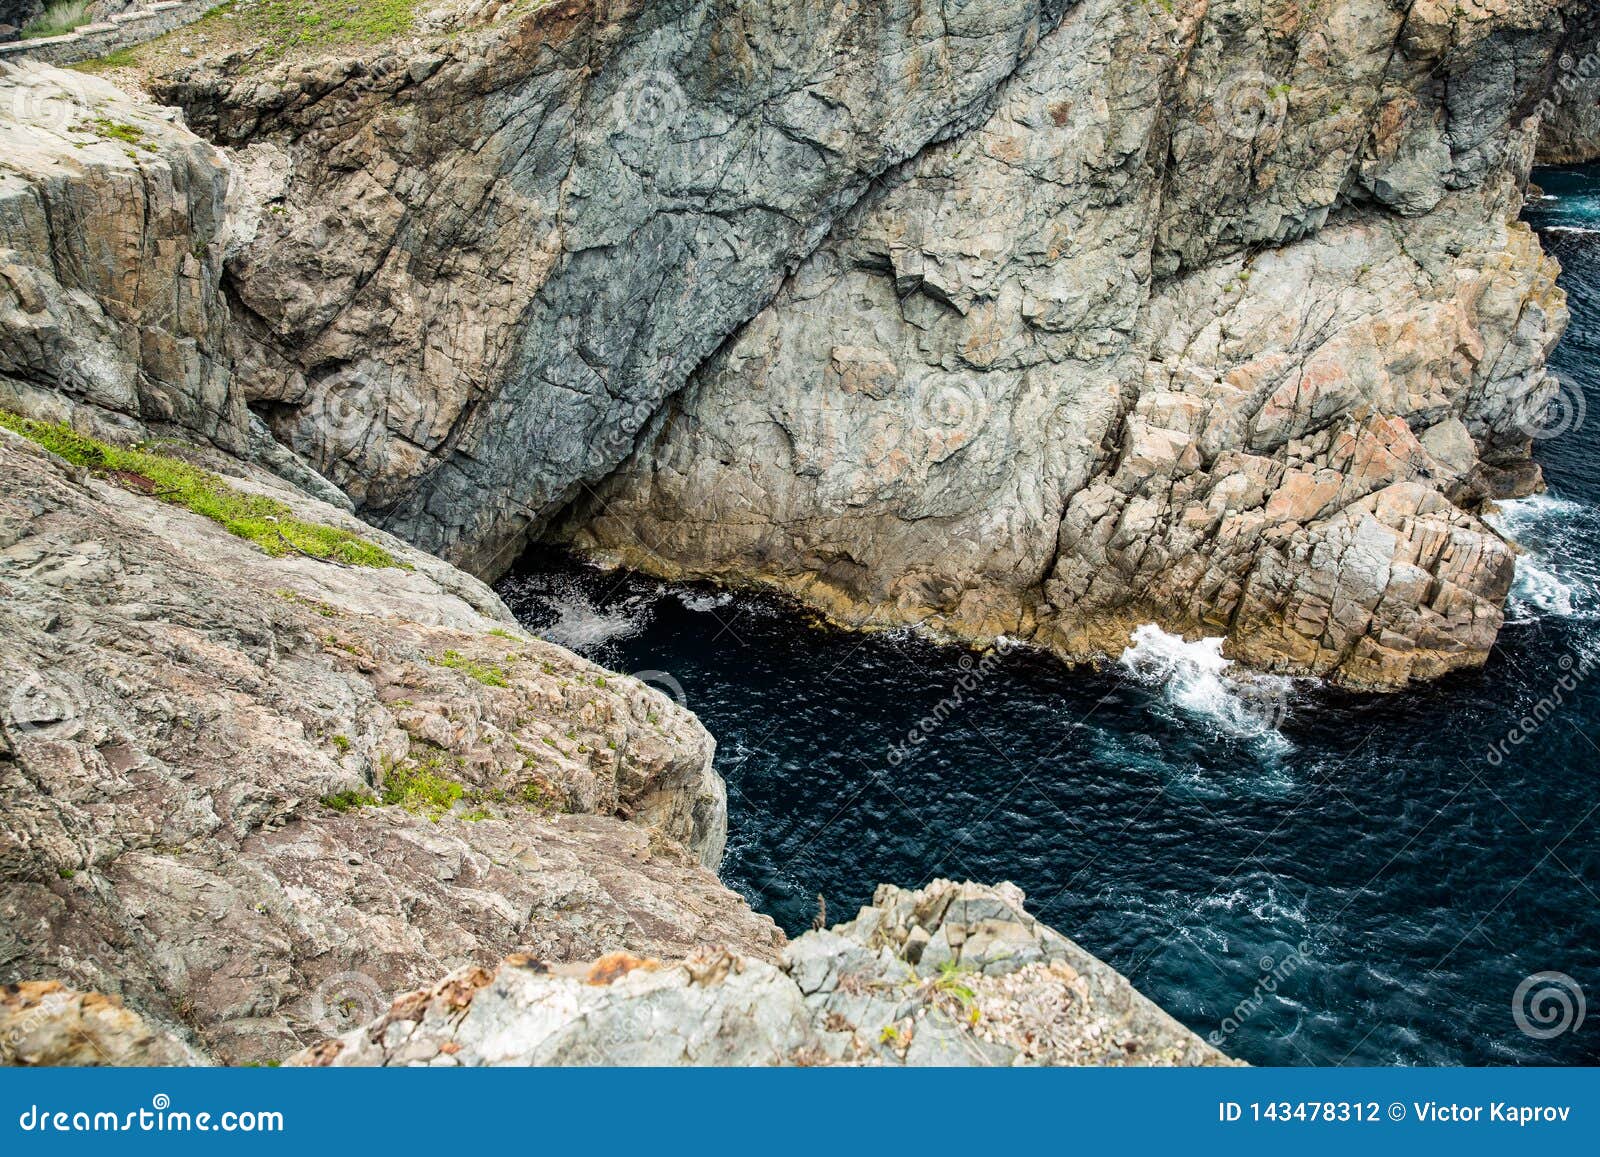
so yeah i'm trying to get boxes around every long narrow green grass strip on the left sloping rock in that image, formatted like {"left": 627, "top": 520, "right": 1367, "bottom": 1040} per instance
{"left": 0, "top": 410, "right": 400, "bottom": 570}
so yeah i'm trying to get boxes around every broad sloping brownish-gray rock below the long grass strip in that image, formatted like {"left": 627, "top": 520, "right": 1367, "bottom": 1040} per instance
{"left": 0, "top": 432, "right": 781, "bottom": 1061}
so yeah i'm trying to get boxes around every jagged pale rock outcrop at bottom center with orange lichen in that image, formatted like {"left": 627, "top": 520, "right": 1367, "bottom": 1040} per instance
{"left": 290, "top": 880, "right": 1230, "bottom": 1066}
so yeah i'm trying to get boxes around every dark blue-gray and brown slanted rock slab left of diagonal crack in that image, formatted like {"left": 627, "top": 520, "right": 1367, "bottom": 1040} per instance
{"left": 157, "top": 0, "right": 1066, "bottom": 573}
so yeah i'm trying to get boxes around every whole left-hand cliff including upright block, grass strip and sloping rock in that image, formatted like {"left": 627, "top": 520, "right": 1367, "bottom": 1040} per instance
{"left": 0, "top": 67, "right": 782, "bottom": 1061}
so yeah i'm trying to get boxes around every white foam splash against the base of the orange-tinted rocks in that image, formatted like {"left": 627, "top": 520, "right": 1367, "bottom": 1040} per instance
{"left": 1122, "top": 623, "right": 1293, "bottom": 747}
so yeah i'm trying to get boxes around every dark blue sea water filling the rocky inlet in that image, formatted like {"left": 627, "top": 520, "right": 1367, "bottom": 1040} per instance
{"left": 501, "top": 170, "right": 1600, "bottom": 1064}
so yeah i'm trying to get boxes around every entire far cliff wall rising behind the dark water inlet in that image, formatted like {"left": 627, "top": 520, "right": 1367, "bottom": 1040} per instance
{"left": 134, "top": 0, "right": 1594, "bottom": 687}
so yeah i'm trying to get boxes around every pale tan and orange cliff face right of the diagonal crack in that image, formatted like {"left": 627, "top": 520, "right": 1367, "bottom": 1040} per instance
{"left": 566, "top": 0, "right": 1566, "bottom": 687}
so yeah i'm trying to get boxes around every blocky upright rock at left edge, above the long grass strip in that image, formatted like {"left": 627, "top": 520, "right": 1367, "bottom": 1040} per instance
{"left": 0, "top": 62, "right": 250, "bottom": 453}
